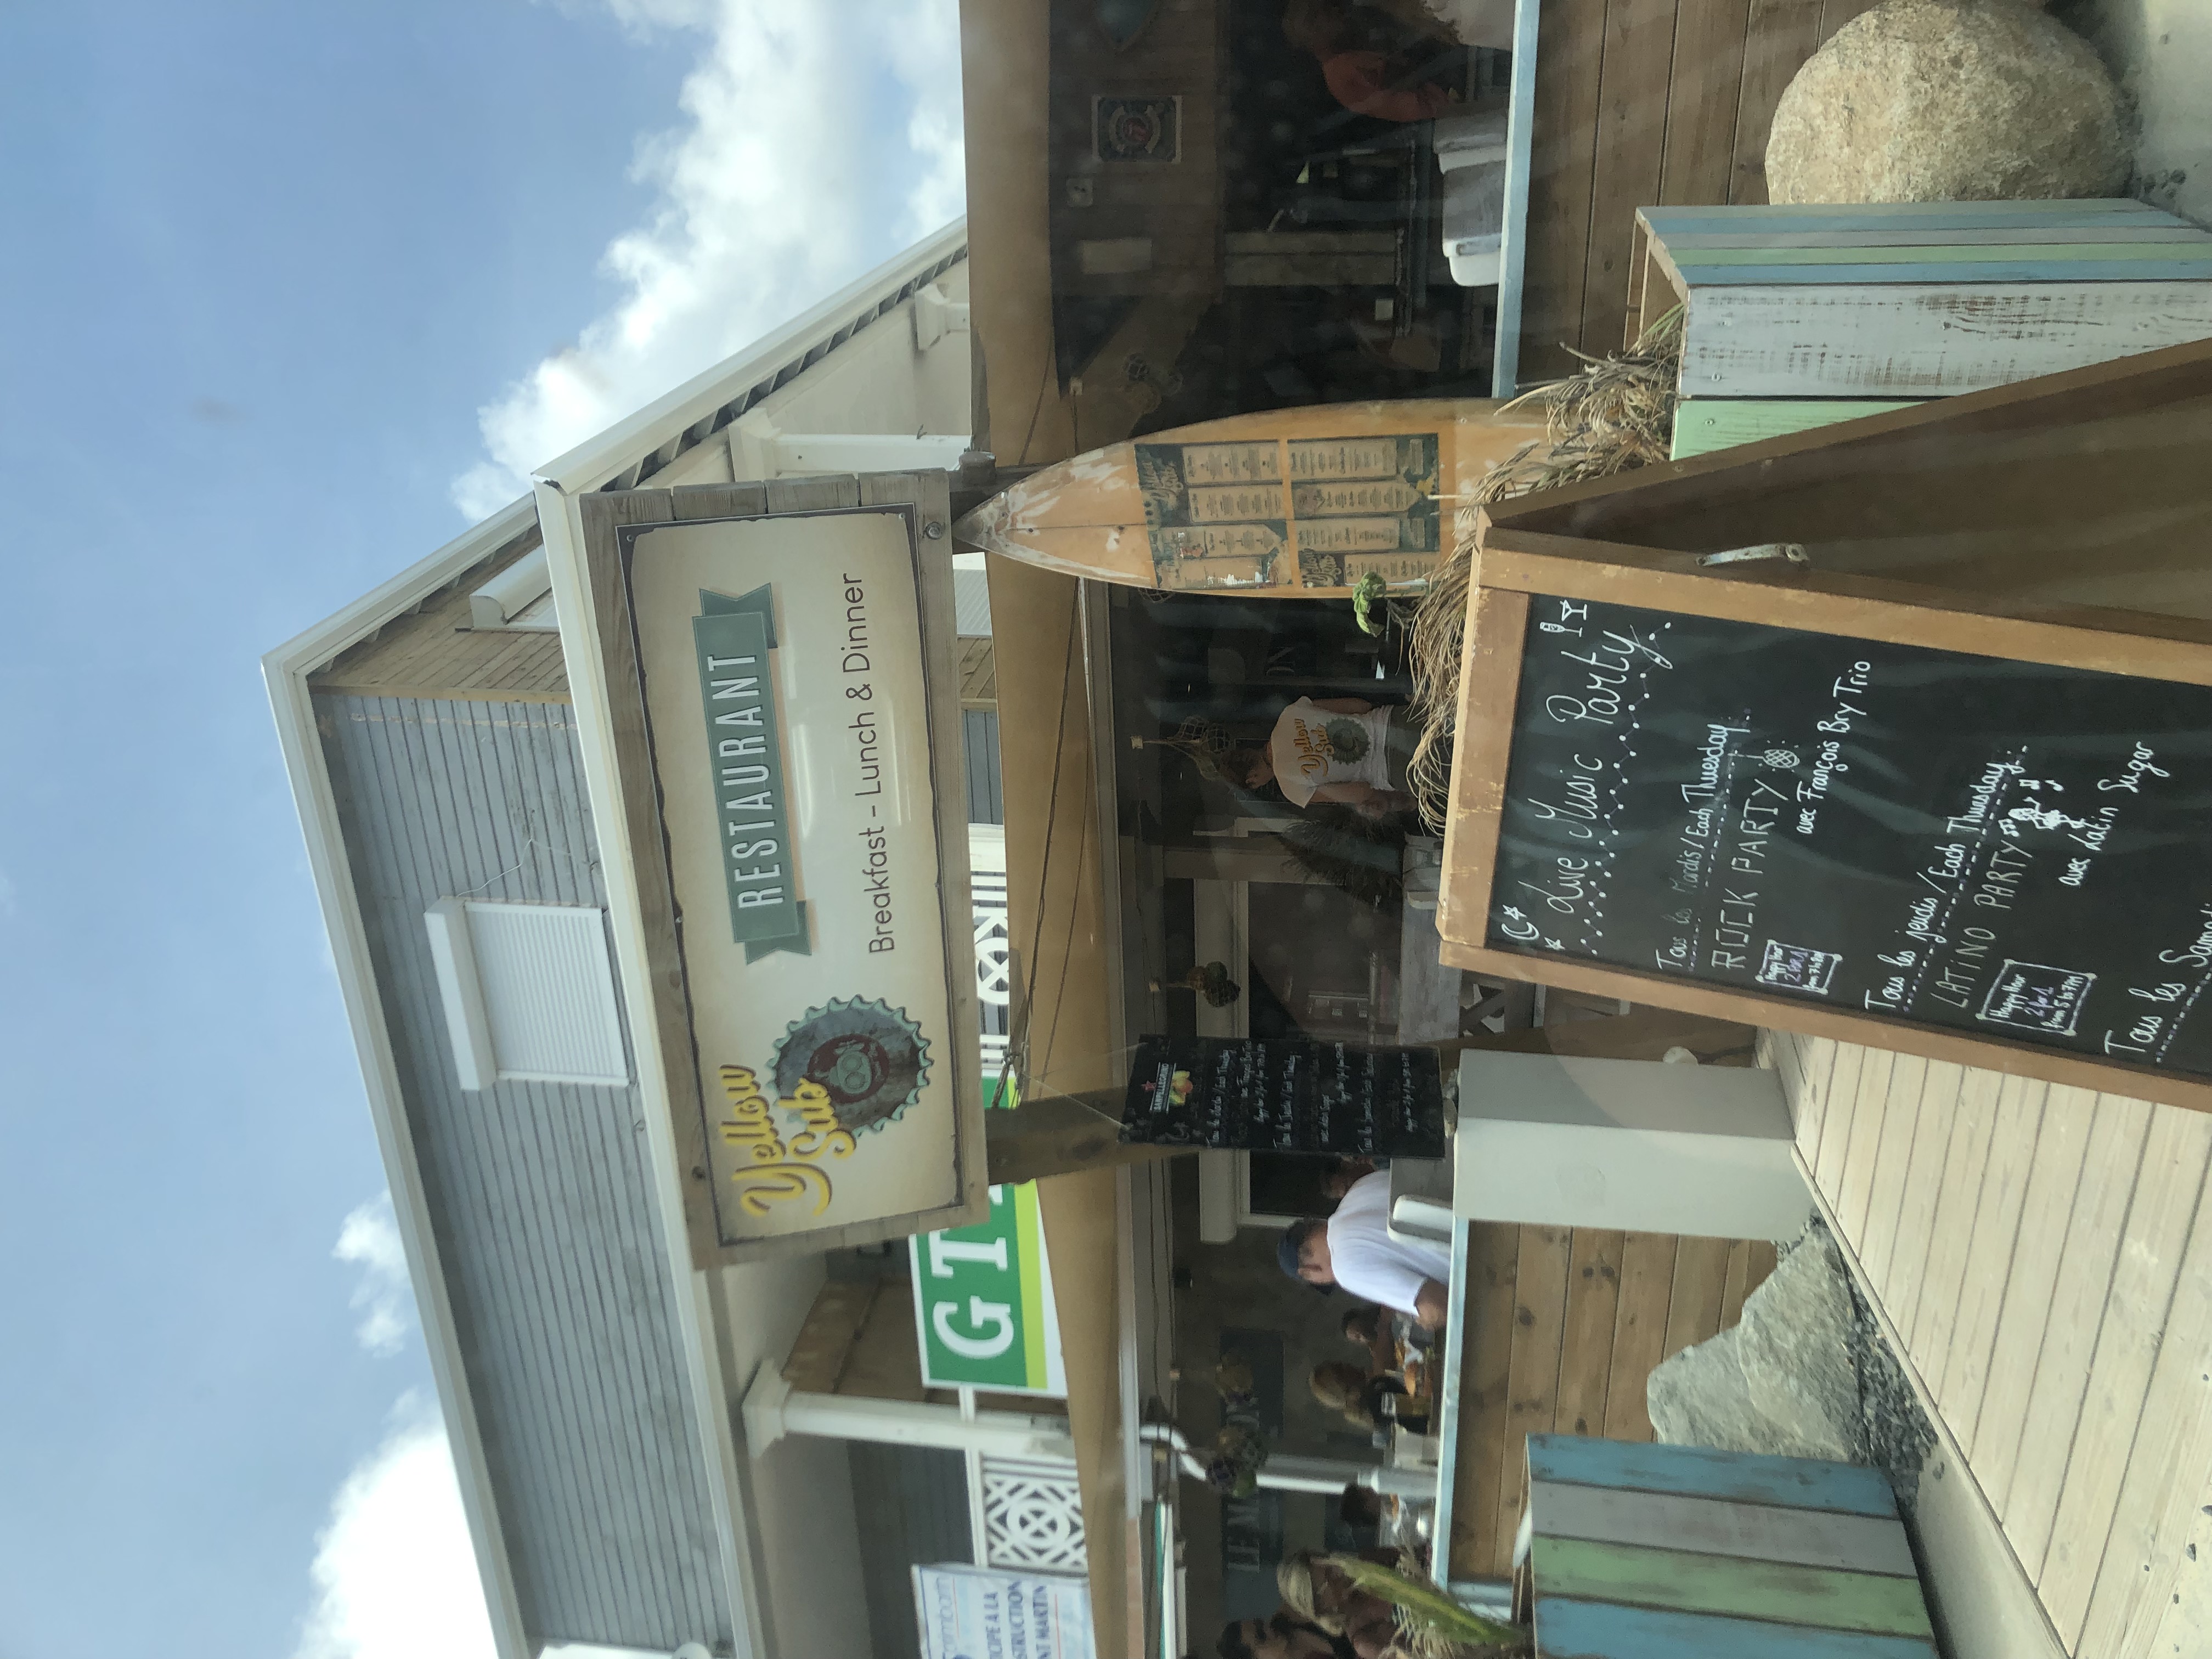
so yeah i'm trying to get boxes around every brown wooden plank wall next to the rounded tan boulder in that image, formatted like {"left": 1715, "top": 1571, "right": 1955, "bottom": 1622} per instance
{"left": 1520, "top": 0, "right": 1876, "bottom": 385}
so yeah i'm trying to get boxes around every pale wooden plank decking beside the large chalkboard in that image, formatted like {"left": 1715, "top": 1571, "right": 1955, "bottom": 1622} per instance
{"left": 1772, "top": 1033, "right": 2212, "bottom": 1659}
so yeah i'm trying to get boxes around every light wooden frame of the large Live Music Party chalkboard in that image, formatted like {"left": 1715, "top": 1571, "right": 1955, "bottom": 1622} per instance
{"left": 1438, "top": 539, "right": 2212, "bottom": 1113}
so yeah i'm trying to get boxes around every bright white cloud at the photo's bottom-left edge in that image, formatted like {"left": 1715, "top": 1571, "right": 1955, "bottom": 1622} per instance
{"left": 294, "top": 1393, "right": 493, "bottom": 1659}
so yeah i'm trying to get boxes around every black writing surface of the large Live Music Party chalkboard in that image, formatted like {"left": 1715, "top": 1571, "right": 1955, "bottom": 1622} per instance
{"left": 1487, "top": 595, "right": 2212, "bottom": 1077}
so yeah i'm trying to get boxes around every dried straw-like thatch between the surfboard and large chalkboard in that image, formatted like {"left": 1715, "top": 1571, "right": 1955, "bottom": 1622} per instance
{"left": 1407, "top": 305, "right": 1681, "bottom": 830}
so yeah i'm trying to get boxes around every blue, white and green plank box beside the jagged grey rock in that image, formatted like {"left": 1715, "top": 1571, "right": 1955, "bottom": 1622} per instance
{"left": 1526, "top": 1434, "right": 1936, "bottom": 1659}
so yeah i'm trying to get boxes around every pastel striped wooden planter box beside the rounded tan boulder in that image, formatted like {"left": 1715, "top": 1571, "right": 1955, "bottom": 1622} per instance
{"left": 1628, "top": 197, "right": 2212, "bottom": 460}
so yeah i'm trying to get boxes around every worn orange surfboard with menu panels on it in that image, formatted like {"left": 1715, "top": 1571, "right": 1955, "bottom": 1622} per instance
{"left": 956, "top": 398, "right": 1544, "bottom": 600}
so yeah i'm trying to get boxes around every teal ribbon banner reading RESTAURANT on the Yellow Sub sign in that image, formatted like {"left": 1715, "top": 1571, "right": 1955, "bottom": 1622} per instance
{"left": 692, "top": 586, "right": 812, "bottom": 962}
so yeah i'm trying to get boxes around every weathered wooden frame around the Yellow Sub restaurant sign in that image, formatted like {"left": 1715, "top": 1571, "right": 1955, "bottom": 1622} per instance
{"left": 566, "top": 473, "right": 989, "bottom": 1269}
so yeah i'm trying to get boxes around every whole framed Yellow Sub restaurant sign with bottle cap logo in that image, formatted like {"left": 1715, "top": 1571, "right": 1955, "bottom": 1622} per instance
{"left": 553, "top": 480, "right": 982, "bottom": 1265}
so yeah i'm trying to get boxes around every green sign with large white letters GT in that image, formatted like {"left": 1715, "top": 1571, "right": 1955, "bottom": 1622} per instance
{"left": 911, "top": 1181, "right": 1068, "bottom": 1398}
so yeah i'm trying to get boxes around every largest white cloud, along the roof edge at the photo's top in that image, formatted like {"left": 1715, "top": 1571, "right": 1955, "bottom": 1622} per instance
{"left": 454, "top": 0, "right": 964, "bottom": 520}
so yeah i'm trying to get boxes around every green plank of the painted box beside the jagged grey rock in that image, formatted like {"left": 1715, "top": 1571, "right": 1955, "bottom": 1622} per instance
{"left": 1528, "top": 1537, "right": 1933, "bottom": 1637}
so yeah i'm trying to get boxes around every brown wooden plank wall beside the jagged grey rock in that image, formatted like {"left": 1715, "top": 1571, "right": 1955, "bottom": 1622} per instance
{"left": 1451, "top": 1221, "right": 1774, "bottom": 1579}
